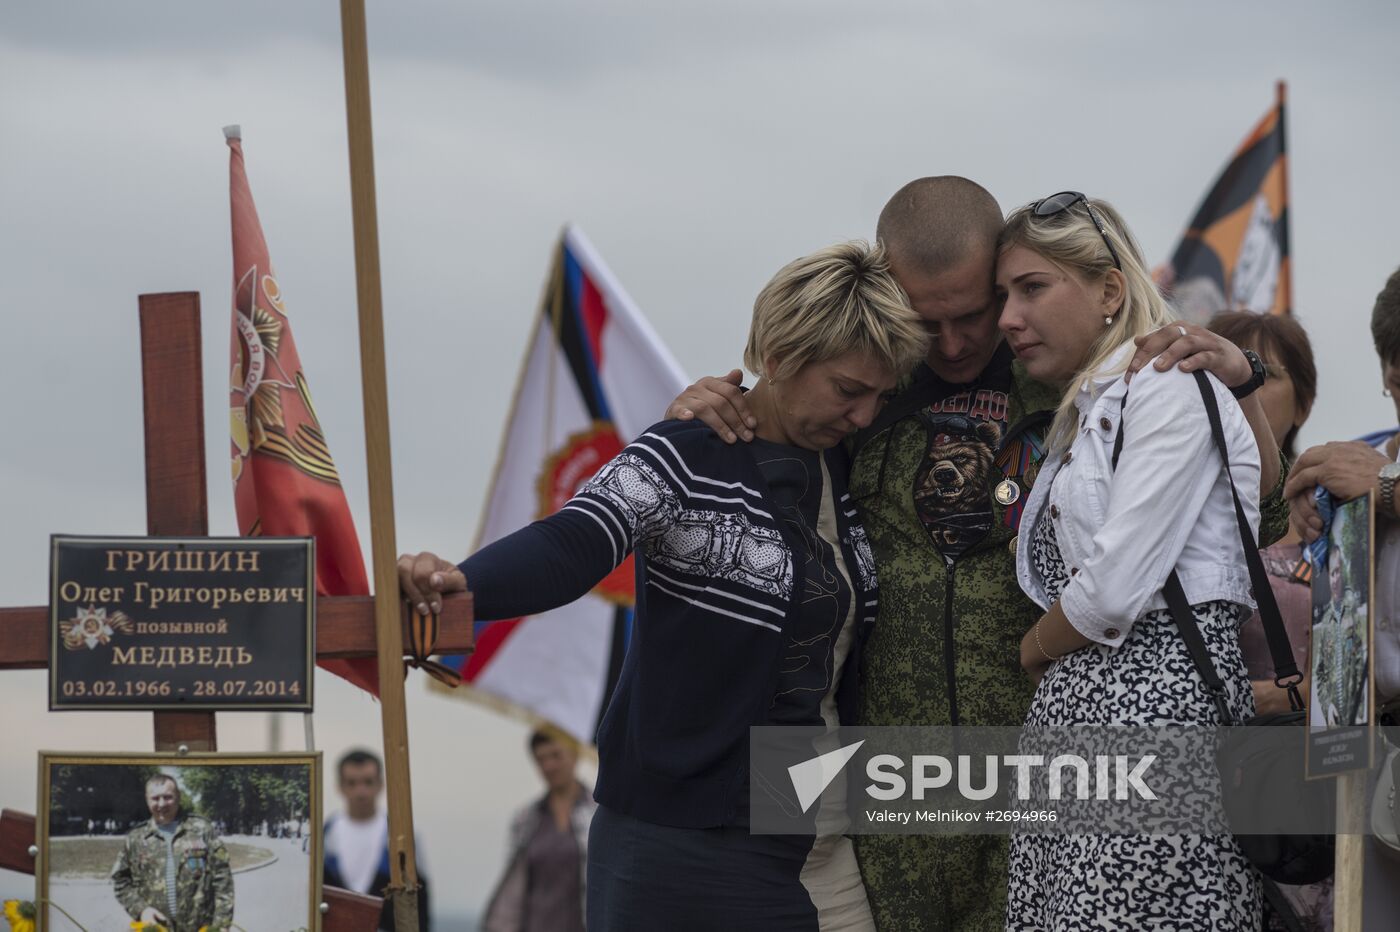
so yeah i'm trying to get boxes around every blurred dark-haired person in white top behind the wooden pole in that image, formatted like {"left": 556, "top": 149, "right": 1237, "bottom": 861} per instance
{"left": 322, "top": 749, "right": 431, "bottom": 932}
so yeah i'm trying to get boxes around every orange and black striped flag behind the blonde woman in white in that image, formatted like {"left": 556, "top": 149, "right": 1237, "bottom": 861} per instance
{"left": 1159, "top": 81, "right": 1292, "bottom": 323}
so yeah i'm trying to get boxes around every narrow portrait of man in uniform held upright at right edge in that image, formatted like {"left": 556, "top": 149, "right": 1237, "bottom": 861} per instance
{"left": 1306, "top": 495, "right": 1376, "bottom": 778}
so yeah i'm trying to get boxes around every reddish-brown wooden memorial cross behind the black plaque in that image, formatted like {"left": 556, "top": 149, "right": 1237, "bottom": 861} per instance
{"left": 0, "top": 292, "right": 472, "bottom": 932}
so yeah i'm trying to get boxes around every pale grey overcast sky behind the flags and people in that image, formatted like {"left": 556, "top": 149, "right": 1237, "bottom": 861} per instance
{"left": 0, "top": 0, "right": 1400, "bottom": 914}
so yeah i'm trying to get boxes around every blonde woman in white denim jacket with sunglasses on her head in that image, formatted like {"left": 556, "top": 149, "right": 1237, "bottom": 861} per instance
{"left": 997, "top": 192, "right": 1267, "bottom": 931}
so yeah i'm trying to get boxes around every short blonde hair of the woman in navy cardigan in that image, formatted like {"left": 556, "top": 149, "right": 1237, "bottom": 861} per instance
{"left": 743, "top": 241, "right": 928, "bottom": 379}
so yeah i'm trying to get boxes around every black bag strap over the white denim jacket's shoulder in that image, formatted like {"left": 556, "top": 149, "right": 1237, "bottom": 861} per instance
{"left": 1113, "top": 369, "right": 1303, "bottom": 725}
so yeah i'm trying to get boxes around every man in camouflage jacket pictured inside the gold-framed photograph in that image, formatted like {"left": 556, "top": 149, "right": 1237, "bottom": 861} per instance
{"left": 112, "top": 774, "right": 234, "bottom": 932}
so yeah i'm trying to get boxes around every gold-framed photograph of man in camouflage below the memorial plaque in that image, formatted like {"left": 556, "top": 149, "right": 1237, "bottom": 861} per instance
{"left": 35, "top": 751, "right": 322, "bottom": 932}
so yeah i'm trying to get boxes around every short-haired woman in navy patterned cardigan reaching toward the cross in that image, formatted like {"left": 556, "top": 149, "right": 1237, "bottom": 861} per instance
{"left": 399, "top": 242, "right": 927, "bottom": 932}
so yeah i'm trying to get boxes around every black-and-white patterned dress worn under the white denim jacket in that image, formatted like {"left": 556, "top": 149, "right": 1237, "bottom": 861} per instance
{"left": 1007, "top": 521, "right": 1261, "bottom": 932}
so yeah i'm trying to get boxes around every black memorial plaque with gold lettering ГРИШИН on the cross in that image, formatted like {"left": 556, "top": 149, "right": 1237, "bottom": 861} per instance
{"left": 49, "top": 535, "right": 316, "bottom": 712}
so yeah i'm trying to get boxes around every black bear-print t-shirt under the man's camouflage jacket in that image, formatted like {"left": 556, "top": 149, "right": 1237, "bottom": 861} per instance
{"left": 914, "top": 346, "right": 1011, "bottom": 560}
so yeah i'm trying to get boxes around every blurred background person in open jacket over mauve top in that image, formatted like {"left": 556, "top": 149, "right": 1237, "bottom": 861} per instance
{"left": 482, "top": 730, "right": 598, "bottom": 932}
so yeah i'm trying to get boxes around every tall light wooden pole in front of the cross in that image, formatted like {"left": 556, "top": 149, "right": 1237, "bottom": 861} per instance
{"left": 340, "top": 0, "right": 419, "bottom": 932}
